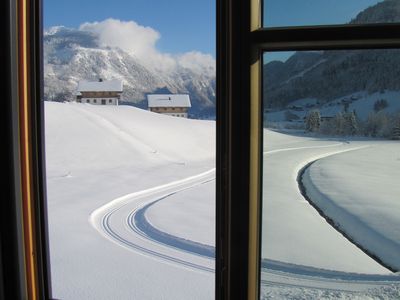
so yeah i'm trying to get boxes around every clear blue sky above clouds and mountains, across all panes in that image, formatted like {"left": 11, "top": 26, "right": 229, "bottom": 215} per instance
{"left": 44, "top": 0, "right": 381, "bottom": 60}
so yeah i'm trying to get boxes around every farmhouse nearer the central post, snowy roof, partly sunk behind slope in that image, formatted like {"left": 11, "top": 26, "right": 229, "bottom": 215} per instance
{"left": 147, "top": 94, "right": 191, "bottom": 118}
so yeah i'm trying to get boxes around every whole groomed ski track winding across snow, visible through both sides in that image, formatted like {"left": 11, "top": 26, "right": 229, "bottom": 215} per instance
{"left": 89, "top": 142, "right": 400, "bottom": 292}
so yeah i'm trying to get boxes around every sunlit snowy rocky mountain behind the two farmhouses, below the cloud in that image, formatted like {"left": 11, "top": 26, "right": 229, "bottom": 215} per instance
{"left": 44, "top": 26, "right": 216, "bottom": 116}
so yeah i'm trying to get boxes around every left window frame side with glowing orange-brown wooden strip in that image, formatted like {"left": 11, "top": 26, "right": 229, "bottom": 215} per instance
{"left": 0, "top": 0, "right": 51, "bottom": 299}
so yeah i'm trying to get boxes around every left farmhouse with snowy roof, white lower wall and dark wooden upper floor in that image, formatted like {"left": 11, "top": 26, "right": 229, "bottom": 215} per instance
{"left": 76, "top": 79, "right": 122, "bottom": 105}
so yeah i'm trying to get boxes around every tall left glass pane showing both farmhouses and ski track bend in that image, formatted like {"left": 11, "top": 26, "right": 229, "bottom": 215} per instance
{"left": 43, "top": 0, "right": 216, "bottom": 300}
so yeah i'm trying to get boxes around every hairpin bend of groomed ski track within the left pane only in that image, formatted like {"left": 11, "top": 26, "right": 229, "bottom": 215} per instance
{"left": 90, "top": 169, "right": 215, "bottom": 272}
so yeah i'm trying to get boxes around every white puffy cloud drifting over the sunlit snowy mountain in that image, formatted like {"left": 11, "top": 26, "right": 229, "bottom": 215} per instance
{"left": 79, "top": 19, "right": 215, "bottom": 74}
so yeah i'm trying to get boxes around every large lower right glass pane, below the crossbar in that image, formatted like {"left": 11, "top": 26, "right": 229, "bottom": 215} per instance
{"left": 261, "top": 49, "right": 400, "bottom": 299}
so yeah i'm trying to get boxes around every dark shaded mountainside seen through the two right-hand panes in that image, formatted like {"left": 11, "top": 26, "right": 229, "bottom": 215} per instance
{"left": 263, "top": 0, "right": 400, "bottom": 108}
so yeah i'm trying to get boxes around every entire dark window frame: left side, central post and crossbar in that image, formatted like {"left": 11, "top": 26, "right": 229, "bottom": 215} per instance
{"left": 0, "top": 0, "right": 400, "bottom": 300}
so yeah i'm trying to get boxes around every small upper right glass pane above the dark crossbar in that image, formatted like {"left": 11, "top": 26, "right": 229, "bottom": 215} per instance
{"left": 263, "top": 0, "right": 400, "bottom": 27}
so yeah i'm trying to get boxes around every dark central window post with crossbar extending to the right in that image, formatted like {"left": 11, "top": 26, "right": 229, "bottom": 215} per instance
{"left": 217, "top": 0, "right": 400, "bottom": 300}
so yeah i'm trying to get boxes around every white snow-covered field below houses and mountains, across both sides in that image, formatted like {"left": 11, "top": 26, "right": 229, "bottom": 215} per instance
{"left": 45, "top": 102, "right": 400, "bottom": 299}
